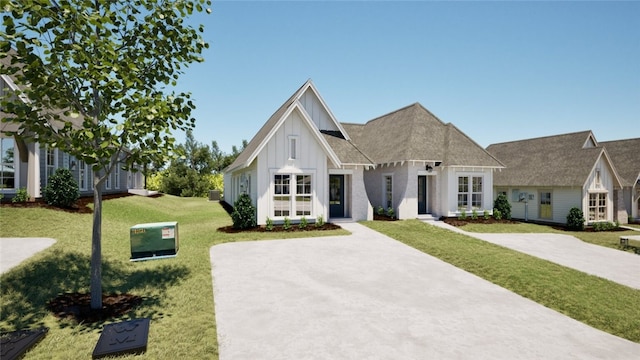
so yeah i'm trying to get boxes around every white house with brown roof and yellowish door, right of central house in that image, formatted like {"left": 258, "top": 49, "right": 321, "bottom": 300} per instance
{"left": 487, "top": 131, "right": 626, "bottom": 223}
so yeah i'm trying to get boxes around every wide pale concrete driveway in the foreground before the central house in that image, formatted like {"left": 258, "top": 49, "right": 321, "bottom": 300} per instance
{"left": 210, "top": 223, "right": 640, "bottom": 360}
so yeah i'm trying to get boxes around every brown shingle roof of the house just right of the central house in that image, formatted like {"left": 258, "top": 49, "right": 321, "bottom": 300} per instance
{"left": 487, "top": 130, "right": 617, "bottom": 186}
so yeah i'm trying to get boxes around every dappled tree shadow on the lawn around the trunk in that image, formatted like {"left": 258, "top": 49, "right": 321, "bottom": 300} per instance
{"left": 0, "top": 250, "right": 190, "bottom": 332}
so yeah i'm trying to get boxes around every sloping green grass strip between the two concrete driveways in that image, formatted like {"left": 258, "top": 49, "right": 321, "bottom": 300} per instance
{"left": 364, "top": 220, "right": 640, "bottom": 343}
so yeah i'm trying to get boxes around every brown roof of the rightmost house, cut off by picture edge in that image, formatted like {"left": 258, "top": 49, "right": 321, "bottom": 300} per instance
{"left": 600, "top": 138, "right": 640, "bottom": 186}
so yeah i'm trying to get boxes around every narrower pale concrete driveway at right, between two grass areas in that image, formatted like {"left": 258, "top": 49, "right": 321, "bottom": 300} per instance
{"left": 426, "top": 221, "right": 640, "bottom": 289}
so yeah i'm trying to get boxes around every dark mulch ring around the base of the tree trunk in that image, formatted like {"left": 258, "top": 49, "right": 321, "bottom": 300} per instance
{"left": 47, "top": 293, "right": 142, "bottom": 323}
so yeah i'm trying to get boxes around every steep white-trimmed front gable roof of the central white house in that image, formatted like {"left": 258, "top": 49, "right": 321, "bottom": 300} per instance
{"left": 224, "top": 80, "right": 358, "bottom": 172}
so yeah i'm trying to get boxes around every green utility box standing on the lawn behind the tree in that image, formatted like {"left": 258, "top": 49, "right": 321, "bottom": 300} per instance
{"left": 130, "top": 221, "right": 179, "bottom": 260}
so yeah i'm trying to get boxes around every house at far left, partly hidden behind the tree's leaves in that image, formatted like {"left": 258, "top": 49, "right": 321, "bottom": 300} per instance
{"left": 0, "top": 57, "right": 144, "bottom": 198}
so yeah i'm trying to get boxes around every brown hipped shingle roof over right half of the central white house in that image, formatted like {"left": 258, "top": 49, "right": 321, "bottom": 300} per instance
{"left": 343, "top": 103, "right": 503, "bottom": 168}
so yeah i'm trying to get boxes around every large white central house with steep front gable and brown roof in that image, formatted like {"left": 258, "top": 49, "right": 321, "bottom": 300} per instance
{"left": 224, "top": 80, "right": 503, "bottom": 224}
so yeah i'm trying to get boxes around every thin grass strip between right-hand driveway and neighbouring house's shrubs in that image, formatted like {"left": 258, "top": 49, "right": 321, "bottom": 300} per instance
{"left": 460, "top": 223, "right": 640, "bottom": 252}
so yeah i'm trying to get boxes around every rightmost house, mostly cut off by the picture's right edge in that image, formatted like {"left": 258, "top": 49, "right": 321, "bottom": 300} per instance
{"left": 600, "top": 138, "right": 640, "bottom": 222}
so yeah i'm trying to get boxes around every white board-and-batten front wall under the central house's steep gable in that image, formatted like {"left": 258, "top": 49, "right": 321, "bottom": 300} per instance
{"left": 257, "top": 110, "right": 329, "bottom": 224}
